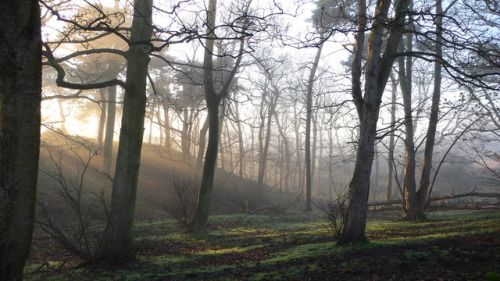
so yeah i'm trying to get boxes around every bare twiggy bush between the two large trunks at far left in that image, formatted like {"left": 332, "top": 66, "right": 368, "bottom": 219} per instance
{"left": 36, "top": 141, "right": 108, "bottom": 262}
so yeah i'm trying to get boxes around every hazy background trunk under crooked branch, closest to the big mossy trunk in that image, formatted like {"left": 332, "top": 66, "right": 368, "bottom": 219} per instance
{"left": 103, "top": 86, "right": 116, "bottom": 171}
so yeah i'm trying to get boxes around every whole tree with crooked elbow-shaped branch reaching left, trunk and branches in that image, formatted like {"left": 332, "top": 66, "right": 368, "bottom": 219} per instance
{"left": 42, "top": 0, "right": 158, "bottom": 263}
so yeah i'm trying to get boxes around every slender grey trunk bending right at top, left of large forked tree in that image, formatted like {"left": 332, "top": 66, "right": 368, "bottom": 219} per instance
{"left": 304, "top": 37, "right": 323, "bottom": 211}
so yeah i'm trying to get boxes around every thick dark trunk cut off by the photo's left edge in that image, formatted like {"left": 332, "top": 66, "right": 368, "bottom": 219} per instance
{"left": 0, "top": 0, "right": 42, "bottom": 281}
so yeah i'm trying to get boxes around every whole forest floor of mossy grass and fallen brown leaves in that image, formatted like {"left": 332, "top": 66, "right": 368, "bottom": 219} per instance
{"left": 26, "top": 210, "right": 500, "bottom": 280}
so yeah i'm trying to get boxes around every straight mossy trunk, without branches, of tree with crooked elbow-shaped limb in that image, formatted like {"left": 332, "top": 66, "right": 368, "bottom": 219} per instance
{"left": 103, "top": 0, "right": 153, "bottom": 263}
